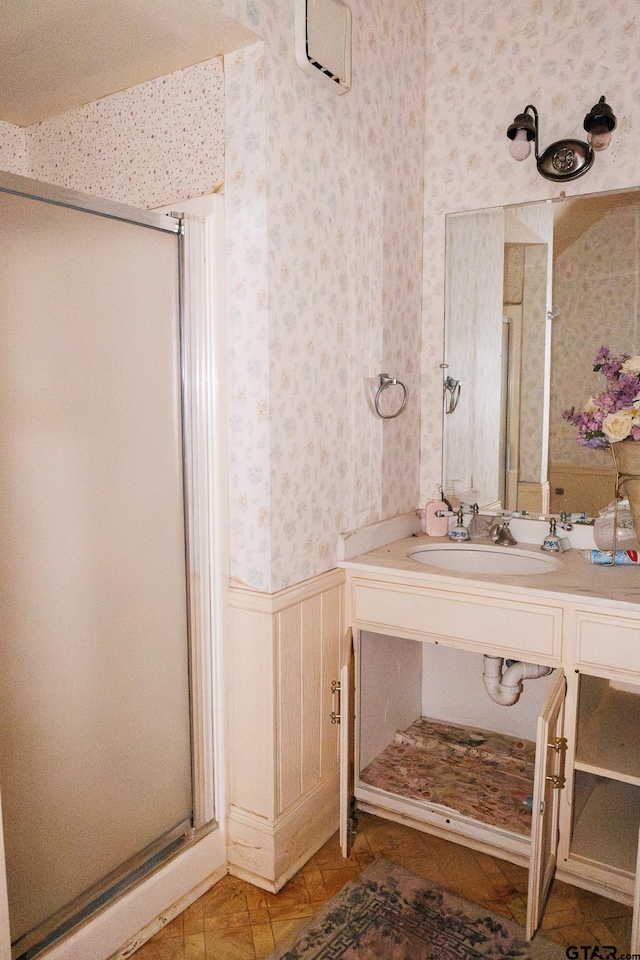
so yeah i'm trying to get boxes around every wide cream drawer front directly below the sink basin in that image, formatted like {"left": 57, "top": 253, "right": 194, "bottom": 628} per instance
{"left": 353, "top": 580, "right": 562, "bottom": 661}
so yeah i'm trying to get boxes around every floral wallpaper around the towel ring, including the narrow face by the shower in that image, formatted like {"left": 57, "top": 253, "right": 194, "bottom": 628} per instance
{"left": 225, "top": 0, "right": 426, "bottom": 591}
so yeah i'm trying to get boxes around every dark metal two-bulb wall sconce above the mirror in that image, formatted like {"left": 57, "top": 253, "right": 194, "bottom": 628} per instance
{"left": 507, "top": 97, "right": 616, "bottom": 180}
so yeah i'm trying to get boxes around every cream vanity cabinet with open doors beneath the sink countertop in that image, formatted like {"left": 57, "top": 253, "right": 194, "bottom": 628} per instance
{"left": 344, "top": 558, "right": 640, "bottom": 952}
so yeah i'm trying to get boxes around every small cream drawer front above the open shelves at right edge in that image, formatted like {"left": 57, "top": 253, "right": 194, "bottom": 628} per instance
{"left": 575, "top": 612, "right": 640, "bottom": 675}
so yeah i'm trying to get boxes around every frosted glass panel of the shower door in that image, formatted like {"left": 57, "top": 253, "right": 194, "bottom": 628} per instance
{"left": 0, "top": 192, "right": 192, "bottom": 942}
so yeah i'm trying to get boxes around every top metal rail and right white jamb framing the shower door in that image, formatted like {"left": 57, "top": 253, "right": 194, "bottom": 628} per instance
{"left": 0, "top": 172, "right": 222, "bottom": 960}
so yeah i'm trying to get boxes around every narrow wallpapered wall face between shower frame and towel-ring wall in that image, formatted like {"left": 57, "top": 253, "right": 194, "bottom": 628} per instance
{"left": 224, "top": 43, "right": 271, "bottom": 585}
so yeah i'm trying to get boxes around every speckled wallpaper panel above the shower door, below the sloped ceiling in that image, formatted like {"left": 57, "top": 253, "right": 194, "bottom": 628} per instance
{"left": 25, "top": 57, "right": 224, "bottom": 208}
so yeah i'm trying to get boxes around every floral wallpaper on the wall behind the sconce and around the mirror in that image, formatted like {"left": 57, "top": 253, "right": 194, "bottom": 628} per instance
{"left": 421, "top": 0, "right": 640, "bottom": 506}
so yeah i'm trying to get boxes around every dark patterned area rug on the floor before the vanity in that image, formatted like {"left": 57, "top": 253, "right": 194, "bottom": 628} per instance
{"left": 268, "top": 860, "right": 565, "bottom": 960}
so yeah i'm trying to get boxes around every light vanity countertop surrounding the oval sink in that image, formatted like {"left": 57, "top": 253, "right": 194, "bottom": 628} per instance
{"left": 338, "top": 534, "right": 640, "bottom": 613}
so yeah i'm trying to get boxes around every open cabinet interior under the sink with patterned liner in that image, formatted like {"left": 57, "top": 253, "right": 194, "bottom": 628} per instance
{"left": 356, "top": 632, "right": 553, "bottom": 849}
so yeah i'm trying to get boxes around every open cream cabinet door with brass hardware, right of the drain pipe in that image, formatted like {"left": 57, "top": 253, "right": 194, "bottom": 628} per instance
{"left": 527, "top": 670, "right": 567, "bottom": 940}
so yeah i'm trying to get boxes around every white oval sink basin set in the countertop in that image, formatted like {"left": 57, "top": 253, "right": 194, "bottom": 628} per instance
{"left": 407, "top": 543, "right": 558, "bottom": 576}
